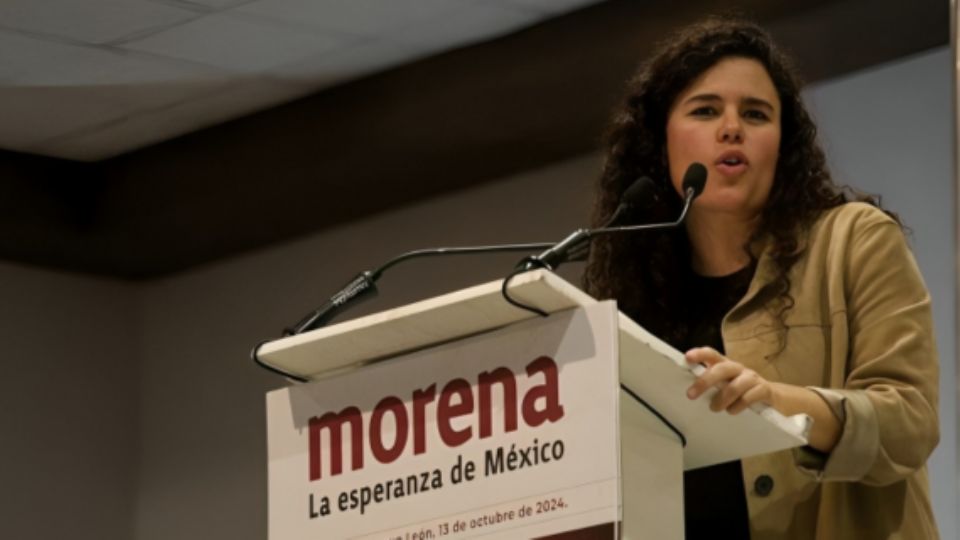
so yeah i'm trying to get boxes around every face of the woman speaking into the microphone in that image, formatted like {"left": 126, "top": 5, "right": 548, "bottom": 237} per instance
{"left": 667, "top": 57, "right": 780, "bottom": 219}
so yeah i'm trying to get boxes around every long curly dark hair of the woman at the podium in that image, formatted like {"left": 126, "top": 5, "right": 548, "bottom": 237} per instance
{"left": 583, "top": 18, "right": 877, "bottom": 346}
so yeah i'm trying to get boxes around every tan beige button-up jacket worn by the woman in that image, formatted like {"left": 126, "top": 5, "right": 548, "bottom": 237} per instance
{"left": 721, "top": 203, "right": 939, "bottom": 540}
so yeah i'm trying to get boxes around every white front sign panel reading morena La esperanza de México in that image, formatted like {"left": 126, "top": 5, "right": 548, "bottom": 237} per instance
{"left": 267, "top": 303, "right": 632, "bottom": 540}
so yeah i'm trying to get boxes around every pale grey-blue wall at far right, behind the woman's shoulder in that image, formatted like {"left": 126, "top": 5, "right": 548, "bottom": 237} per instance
{"left": 807, "top": 47, "right": 960, "bottom": 538}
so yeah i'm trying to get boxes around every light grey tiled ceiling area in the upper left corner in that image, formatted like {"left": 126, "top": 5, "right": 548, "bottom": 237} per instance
{"left": 0, "top": 0, "right": 608, "bottom": 160}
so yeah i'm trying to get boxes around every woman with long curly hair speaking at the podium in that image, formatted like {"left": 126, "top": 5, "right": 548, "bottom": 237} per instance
{"left": 585, "top": 16, "right": 939, "bottom": 540}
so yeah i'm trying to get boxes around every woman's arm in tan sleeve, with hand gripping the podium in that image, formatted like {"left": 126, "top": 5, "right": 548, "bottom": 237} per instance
{"left": 687, "top": 208, "right": 939, "bottom": 485}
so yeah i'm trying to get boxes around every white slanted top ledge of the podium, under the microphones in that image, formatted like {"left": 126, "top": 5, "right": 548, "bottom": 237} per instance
{"left": 257, "top": 270, "right": 811, "bottom": 469}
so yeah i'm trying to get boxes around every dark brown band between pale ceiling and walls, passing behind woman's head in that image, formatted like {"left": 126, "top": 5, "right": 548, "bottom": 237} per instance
{"left": 0, "top": 0, "right": 950, "bottom": 279}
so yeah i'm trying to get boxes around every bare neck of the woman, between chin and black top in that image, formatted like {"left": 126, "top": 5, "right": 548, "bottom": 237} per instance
{"left": 686, "top": 212, "right": 757, "bottom": 276}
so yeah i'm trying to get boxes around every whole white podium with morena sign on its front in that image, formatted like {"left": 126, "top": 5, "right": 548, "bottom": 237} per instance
{"left": 255, "top": 270, "right": 811, "bottom": 540}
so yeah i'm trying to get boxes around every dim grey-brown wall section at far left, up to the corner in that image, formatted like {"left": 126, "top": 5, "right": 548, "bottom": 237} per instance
{"left": 0, "top": 264, "right": 139, "bottom": 540}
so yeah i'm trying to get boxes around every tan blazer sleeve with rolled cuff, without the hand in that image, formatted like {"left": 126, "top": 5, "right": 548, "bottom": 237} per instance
{"left": 814, "top": 209, "right": 940, "bottom": 485}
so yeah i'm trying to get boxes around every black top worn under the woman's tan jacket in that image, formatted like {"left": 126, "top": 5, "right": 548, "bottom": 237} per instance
{"left": 681, "top": 265, "right": 754, "bottom": 540}
